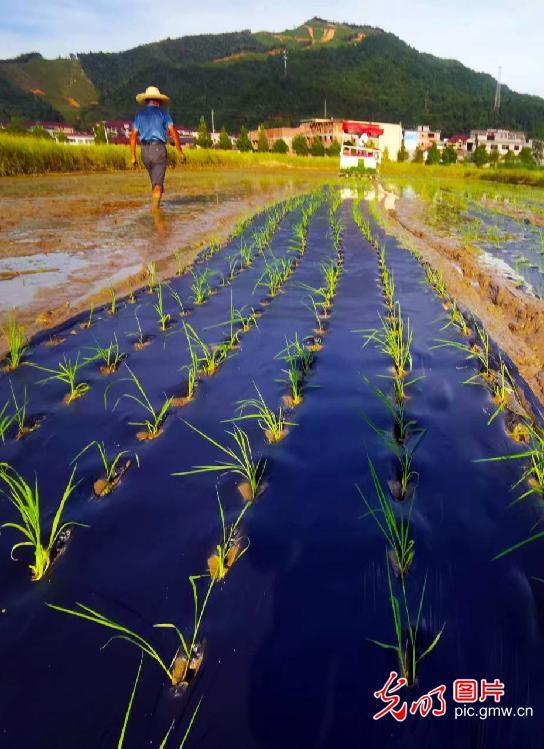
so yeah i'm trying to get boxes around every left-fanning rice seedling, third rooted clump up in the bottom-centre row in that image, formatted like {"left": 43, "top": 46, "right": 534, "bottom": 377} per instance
{"left": 172, "top": 421, "right": 266, "bottom": 500}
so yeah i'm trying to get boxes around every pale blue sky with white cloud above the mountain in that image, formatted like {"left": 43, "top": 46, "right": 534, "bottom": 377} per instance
{"left": 0, "top": 0, "right": 544, "bottom": 96}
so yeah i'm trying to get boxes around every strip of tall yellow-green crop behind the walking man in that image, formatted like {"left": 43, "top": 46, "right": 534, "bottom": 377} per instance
{"left": 0, "top": 135, "right": 338, "bottom": 177}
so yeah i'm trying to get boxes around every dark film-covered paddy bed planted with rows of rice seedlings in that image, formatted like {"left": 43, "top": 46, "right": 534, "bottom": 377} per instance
{"left": 0, "top": 182, "right": 544, "bottom": 749}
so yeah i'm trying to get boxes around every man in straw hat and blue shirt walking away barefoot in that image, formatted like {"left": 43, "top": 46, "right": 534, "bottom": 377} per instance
{"left": 130, "top": 86, "right": 185, "bottom": 208}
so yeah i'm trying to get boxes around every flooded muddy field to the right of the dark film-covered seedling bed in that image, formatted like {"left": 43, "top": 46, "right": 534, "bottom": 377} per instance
{"left": 376, "top": 179, "right": 544, "bottom": 403}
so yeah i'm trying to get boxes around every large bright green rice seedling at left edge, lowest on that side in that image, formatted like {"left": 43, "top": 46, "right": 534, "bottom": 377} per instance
{"left": 0, "top": 463, "right": 82, "bottom": 581}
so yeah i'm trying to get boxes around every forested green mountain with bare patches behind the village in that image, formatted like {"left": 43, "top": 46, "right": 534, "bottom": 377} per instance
{"left": 0, "top": 18, "right": 544, "bottom": 137}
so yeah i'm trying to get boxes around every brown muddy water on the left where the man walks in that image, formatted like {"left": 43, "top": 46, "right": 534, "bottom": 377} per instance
{"left": 0, "top": 170, "right": 326, "bottom": 330}
